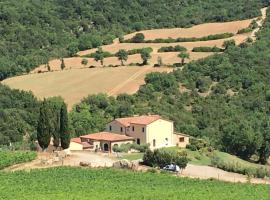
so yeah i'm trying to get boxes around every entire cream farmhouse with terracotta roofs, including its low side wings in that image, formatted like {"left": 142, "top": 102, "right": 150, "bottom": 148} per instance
{"left": 70, "top": 115, "right": 189, "bottom": 152}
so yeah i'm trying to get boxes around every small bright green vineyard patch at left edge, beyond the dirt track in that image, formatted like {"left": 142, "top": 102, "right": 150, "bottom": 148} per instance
{"left": 0, "top": 151, "right": 37, "bottom": 170}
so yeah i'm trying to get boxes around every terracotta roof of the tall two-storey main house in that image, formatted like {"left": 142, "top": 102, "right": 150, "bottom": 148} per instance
{"left": 115, "top": 115, "right": 161, "bottom": 127}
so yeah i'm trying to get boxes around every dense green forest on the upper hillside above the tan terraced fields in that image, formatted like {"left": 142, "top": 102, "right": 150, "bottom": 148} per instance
{"left": 0, "top": 0, "right": 266, "bottom": 80}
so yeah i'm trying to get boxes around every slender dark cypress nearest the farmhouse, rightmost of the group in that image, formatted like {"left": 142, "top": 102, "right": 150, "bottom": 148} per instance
{"left": 60, "top": 103, "right": 70, "bottom": 149}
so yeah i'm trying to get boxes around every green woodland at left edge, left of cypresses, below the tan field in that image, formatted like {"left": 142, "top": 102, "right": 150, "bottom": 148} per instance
{"left": 0, "top": 84, "right": 39, "bottom": 149}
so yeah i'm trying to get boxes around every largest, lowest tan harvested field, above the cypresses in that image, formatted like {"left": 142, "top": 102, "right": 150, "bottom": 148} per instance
{"left": 3, "top": 66, "right": 172, "bottom": 109}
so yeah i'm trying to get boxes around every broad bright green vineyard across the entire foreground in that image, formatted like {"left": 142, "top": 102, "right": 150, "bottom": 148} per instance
{"left": 0, "top": 167, "right": 270, "bottom": 200}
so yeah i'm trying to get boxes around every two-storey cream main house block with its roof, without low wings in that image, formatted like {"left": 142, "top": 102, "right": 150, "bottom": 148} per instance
{"left": 106, "top": 115, "right": 174, "bottom": 149}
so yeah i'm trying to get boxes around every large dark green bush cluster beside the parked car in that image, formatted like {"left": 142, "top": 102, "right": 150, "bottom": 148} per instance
{"left": 143, "top": 148, "right": 188, "bottom": 169}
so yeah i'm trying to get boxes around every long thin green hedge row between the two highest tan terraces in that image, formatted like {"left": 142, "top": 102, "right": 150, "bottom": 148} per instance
{"left": 123, "top": 33, "right": 234, "bottom": 43}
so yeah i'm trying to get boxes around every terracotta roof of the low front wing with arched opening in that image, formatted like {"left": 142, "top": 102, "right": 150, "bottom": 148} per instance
{"left": 81, "top": 132, "right": 134, "bottom": 142}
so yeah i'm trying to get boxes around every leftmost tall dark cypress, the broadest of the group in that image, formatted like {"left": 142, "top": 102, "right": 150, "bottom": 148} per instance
{"left": 37, "top": 99, "right": 51, "bottom": 150}
